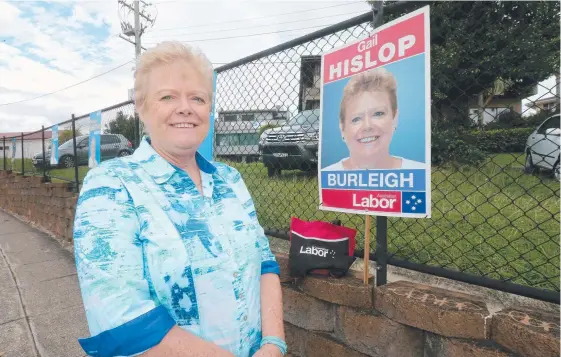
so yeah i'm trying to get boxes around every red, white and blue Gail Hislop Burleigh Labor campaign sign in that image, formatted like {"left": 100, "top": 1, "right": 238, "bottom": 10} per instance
{"left": 318, "top": 6, "right": 431, "bottom": 218}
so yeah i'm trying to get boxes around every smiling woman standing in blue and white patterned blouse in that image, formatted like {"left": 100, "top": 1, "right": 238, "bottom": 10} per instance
{"left": 74, "top": 42, "right": 286, "bottom": 357}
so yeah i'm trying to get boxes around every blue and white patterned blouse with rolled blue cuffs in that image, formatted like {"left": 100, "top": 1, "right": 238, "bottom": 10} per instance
{"left": 74, "top": 138, "right": 279, "bottom": 357}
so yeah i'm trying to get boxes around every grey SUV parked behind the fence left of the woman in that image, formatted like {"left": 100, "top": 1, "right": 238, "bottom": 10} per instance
{"left": 32, "top": 134, "right": 133, "bottom": 168}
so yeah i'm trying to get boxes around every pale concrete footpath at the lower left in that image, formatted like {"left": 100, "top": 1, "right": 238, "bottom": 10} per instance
{"left": 0, "top": 210, "right": 89, "bottom": 357}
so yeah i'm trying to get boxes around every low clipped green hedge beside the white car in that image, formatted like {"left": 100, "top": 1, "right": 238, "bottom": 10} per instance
{"left": 473, "top": 128, "right": 535, "bottom": 154}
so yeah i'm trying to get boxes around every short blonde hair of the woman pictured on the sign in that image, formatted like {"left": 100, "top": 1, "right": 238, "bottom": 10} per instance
{"left": 339, "top": 67, "right": 397, "bottom": 125}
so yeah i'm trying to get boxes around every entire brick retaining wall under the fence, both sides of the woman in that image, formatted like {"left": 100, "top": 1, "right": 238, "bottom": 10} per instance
{"left": 0, "top": 171, "right": 560, "bottom": 357}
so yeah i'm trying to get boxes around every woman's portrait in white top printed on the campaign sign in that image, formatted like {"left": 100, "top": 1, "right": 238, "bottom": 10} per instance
{"left": 323, "top": 67, "right": 425, "bottom": 171}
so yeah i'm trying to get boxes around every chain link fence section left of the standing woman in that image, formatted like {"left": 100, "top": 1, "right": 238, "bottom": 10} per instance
{"left": 0, "top": 101, "right": 137, "bottom": 190}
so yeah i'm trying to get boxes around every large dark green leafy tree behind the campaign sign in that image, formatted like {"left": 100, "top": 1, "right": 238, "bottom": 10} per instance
{"left": 368, "top": 1, "right": 560, "bottom": 126}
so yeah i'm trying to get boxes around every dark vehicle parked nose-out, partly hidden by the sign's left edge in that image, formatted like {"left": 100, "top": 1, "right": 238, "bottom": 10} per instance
{"left": 259, "top": 109, "right": 319, "bottom": 177}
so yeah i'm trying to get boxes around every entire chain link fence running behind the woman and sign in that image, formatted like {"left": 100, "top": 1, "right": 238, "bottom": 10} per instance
{"left": 0, "top": 2, "right": 560, "bottom": 303}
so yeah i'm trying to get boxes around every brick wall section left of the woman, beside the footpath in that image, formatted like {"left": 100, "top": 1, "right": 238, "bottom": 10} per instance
{"left": 0, "top": 171, "right": 78, "bottom": 243}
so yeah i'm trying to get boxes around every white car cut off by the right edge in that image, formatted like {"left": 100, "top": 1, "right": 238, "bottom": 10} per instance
{"left": 524, "top": 114, "right": 561, "bottom": 180}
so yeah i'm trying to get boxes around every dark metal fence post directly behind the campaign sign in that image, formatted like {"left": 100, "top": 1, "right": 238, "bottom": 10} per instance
{"left": 372, "top": 0, "right": 388, "bottom": 286}
